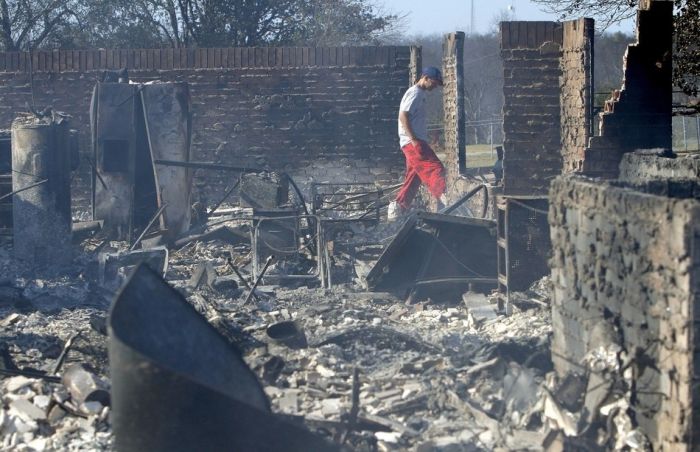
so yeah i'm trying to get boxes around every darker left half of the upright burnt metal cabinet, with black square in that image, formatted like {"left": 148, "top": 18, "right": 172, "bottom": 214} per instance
{"left": 91, "top": 83, "right": 138, "bottom": 240}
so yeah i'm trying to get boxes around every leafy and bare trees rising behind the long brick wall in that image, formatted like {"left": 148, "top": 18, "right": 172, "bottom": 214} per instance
{"left": 0, "top": 0, "right": 401, "bottom": 51}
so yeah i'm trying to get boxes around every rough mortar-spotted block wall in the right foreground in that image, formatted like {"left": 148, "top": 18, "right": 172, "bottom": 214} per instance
{"left": 549, "top": 176, "right": 700, "bottom": 451}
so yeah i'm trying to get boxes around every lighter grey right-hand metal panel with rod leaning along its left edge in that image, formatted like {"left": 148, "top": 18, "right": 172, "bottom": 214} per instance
{"left": 141, "top": 83, "right": 193, "bottom": 239}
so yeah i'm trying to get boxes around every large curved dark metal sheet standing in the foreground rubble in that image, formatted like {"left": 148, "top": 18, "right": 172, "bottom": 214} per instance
{"left": 108, "top": 265, "right": 338, "bottom": 452}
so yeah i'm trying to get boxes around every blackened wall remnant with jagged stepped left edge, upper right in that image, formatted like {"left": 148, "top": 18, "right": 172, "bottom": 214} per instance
{"left": 583, "top": 1, "right": 673, "bottom": 178}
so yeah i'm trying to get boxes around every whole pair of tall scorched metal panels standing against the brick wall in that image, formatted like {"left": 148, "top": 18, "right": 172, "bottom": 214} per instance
{"left": 91, "top": 83, "right": 192, "bottom": 241}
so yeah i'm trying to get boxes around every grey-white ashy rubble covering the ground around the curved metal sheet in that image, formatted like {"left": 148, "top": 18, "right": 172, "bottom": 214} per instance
{"left": 0, "top": 214, "right": 551, "bottom": 451}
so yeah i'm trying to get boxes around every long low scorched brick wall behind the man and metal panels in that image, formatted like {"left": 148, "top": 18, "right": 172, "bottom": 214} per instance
{"left": 0, "top": 47, "right": 411, "bottom": 212}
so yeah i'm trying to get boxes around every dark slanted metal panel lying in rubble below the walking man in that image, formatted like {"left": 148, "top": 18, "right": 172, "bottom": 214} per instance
{"left": 366, "top": 212, "right": 498, "bottom": 296}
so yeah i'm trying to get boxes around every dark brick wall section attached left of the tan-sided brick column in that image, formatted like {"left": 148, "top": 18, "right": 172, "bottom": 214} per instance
{"left": 501, "top": 22, "right": 563, "bottom": 196}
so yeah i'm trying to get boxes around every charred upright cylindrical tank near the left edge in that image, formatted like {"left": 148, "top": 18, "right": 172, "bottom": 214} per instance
{"left": 12, "top": 115, "right": 71, "bottom": 266}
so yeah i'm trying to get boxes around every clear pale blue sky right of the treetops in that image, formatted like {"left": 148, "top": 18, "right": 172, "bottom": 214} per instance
{"left": 374, "top": 0, "right": 634, "bottom": 35}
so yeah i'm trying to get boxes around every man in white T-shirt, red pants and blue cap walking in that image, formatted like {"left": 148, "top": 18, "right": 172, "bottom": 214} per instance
{"left": 388, "top": 66, "right": 446, "bottom": 220}
